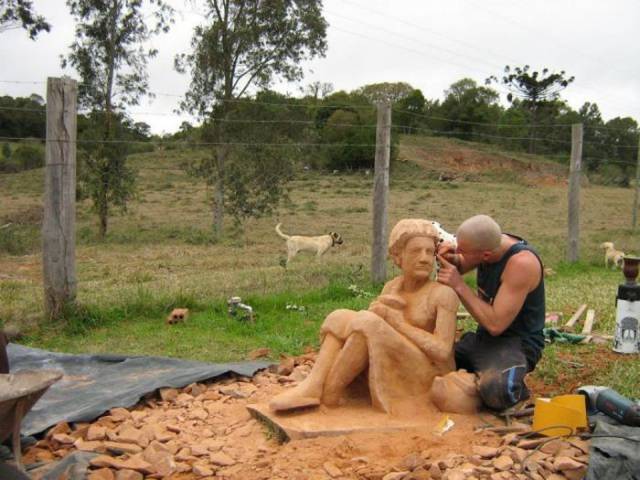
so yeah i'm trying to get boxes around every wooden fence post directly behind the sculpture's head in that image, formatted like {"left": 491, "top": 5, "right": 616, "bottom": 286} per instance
{"left": 371, "top": 102, "right": 391, "bottom": 283}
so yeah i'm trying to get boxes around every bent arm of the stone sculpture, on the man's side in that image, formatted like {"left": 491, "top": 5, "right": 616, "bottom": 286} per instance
{"left": 393, "top": 288, "right": 460, "bottom": 363}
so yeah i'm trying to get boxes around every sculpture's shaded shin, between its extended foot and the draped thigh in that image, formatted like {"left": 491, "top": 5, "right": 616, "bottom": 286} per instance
{"left": 322, "top": 333, "right": 369, "bottom": 406}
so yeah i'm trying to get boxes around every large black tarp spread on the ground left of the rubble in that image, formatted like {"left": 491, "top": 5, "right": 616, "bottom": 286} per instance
{"left": 8, "top": 344, "right": 270, "bottom": 435}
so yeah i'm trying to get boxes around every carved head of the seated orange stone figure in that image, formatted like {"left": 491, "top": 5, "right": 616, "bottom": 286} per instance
{"left": 389, "top": 218, "right": 438, "bottom": 278}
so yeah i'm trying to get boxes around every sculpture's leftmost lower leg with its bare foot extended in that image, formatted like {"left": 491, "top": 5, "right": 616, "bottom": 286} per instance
{"left": 269, "top": 334, "right": 342, "bottom": 411}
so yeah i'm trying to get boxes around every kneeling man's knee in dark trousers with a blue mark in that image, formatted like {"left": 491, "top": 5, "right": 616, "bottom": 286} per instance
{"left": 478, "top": 365, "right": 529, "bottom": 411}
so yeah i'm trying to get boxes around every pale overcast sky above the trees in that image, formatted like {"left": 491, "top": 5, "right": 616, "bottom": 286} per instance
{"left": 0, "top": 0, "right": 640, "bottom": 133}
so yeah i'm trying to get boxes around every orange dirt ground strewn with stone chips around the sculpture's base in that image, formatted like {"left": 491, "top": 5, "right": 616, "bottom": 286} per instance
{"left": 24, "top": 353, "right": 588, "bottom": 480}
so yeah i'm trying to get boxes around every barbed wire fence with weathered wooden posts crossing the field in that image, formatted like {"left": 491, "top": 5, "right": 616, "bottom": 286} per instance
{"left": 0, "top": 77, "right": 640, "bottom": 316}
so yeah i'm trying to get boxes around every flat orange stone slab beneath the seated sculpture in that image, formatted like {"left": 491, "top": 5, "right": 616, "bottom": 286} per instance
{"left": 247, "top": 402, "right": 443, "bottom": 441}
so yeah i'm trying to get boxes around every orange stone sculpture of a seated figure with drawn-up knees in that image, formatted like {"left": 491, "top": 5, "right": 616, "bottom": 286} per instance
{"left": 270, "top": 219, "right": 473, "bottom": 416}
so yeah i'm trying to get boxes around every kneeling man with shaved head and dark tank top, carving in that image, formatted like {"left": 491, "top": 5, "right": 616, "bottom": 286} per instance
{"left": 436, "top": 215, "right": 545, "bottom": 410}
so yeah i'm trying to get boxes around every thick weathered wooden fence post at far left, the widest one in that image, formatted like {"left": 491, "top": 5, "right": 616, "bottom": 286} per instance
{"left": 42, "top": 77, "right": 78, "bottom": 318}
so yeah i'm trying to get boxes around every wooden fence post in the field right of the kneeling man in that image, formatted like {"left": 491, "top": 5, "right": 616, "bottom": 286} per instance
{"left": 567, "top": 123, "right": 582, "bottom": 262}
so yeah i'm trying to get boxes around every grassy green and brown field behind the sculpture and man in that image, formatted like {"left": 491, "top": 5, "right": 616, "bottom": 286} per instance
{"left": 0, "top": 139, "right": 640, "bottom": 396}
